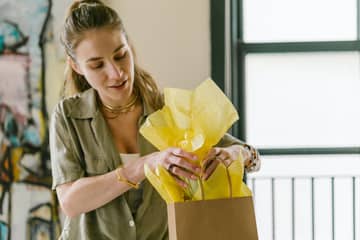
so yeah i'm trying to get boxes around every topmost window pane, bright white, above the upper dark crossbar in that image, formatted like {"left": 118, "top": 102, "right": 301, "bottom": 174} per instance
{"left": 243, "top": 0, "right": 357, "bottom": 42}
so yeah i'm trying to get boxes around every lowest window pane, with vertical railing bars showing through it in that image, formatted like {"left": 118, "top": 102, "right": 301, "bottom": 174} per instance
{"left": 247, "top": 155, "right": 360, "bottom": 240}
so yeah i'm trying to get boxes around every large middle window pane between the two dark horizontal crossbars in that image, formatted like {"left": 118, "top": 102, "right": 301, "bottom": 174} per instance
{"left": 246, "top": 52, "right": 360, "bottom": 147}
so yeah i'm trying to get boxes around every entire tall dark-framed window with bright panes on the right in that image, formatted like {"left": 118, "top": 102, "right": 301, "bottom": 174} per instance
{"left": 211, "top": 0, "right": 360, "bottom": 239}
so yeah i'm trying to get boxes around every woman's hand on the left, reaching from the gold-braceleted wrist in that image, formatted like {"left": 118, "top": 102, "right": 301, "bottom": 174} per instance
{"left": 145, "top": 147, "right": 201, "bottom": 187}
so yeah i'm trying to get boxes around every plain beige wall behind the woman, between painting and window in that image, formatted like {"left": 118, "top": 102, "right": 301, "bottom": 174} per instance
{"left": 46, "top": 0, "right": 211, "bottom": 112}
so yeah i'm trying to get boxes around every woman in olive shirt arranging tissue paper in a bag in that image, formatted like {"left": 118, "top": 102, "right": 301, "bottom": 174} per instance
{"left": 50, "top": 0, "right": 259, "bottom": 240}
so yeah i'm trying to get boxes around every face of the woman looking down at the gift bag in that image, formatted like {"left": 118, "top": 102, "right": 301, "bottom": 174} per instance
{"left": 71, "top": 28, "right": 134, "bottom": 106}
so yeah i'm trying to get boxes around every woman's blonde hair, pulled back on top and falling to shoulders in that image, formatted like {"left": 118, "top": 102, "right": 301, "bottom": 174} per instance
{"left": 60, "top": 0, "right": 163, "bottom": 110}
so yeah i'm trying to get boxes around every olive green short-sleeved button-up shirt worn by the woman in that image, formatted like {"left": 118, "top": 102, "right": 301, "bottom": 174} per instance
{"left": 50, "top": 89, "right": 239, "bottom": 240}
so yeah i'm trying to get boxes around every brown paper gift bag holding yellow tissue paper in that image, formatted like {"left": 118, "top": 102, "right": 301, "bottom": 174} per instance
{"left": 167, "top": 197, "right": 258, "bottom": 240}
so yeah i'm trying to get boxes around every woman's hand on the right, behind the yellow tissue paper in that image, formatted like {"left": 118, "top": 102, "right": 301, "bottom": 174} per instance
{"left": 202, "top": 145, "right": 243, "bottom": 180}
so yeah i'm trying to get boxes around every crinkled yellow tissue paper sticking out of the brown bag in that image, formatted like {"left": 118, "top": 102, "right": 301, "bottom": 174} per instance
{"left": 140, "top": 79, "right": 251, "bottom": 203}
